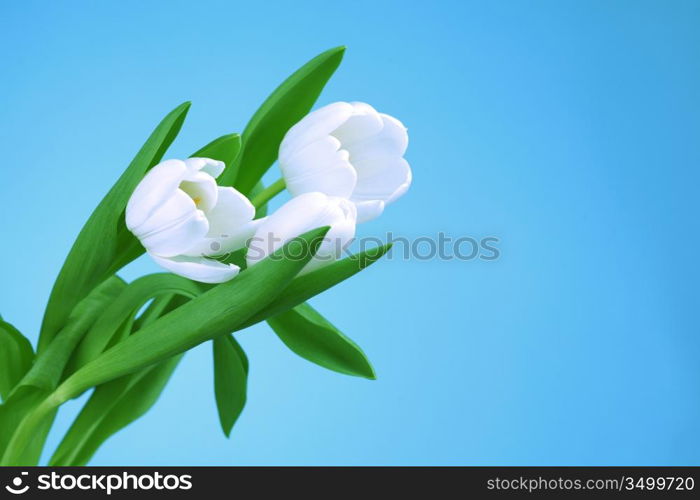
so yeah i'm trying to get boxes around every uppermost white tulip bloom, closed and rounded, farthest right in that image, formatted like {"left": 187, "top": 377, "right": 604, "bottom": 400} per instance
{"left": 279, "top": 102, "right": 411, "bottom": 222}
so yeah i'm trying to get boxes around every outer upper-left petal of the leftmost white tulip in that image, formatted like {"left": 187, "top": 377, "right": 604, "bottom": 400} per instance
{"left": 126, "top": 160, "right": 187, "bottom": 232}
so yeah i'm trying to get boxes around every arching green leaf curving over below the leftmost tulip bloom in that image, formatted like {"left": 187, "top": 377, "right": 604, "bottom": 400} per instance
{"left": 69, "top": 273, "right": 202, "bottom": 372}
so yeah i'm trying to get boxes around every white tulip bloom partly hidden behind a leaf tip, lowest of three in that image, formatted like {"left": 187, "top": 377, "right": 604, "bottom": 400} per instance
{"left": 246, "top": 193, "right": 357, "bottom": 273}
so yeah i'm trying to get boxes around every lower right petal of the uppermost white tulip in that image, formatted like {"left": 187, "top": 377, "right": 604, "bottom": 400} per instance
{"left": 350, "top": 157, "right": 412, "bottom": 204}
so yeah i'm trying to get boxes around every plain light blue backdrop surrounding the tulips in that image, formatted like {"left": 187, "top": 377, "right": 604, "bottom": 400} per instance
{"left": 0, "top": 0, "right": 700, "bottom": 465}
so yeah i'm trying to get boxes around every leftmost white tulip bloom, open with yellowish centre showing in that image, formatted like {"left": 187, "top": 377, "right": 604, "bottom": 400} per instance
{"left": 126, "top": 158, "right": 259, "bottom": 283}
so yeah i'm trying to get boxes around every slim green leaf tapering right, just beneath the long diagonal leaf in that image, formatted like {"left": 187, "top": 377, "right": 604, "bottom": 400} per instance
{"left": 238, "top": 243, "right": 391, "bottom": 330}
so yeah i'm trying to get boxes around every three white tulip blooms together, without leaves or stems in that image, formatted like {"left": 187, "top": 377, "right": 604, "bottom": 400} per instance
{"left": 126, "top": 102, "right": 411, "bottom": 283}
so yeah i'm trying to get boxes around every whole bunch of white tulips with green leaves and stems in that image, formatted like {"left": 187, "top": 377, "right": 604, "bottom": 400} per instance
{"left": 0, "top": 47, "right": 411, "bottom": 465}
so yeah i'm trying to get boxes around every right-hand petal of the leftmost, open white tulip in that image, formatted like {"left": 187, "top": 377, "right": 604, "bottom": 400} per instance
{"left": 186, "top": 187, "right": 262, "bottom": 256}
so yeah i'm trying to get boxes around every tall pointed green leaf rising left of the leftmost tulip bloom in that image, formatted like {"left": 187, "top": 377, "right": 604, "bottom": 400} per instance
{"left": 37, "top": 102, "right": 190, "bottom": 352}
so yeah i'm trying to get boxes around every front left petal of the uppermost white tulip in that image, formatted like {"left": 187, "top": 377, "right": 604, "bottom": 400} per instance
{"left": 280, "top": 136, "right": 357, "bottom": 198}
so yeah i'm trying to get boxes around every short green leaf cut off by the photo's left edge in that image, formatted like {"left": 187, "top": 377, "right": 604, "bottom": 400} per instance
{"left": 0, "top": 318, "right": 34, "bottom": 401}
